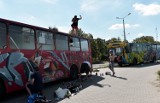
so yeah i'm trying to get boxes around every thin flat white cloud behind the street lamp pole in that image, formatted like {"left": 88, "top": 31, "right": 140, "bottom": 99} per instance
{"left": 109, "top": 24, "right": 140, "bottom": 30}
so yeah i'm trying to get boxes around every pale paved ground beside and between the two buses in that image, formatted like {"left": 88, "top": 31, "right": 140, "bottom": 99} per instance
{"left": 0, "top": 64, "right": 160, "bottom": 103}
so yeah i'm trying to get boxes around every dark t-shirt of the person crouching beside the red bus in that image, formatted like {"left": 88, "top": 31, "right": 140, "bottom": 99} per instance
{"left": 31, "top": 72, "right": 43, "bottom": 90}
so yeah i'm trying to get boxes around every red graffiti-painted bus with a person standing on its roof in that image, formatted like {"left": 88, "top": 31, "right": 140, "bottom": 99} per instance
{"left": 0, "top": 18, "right": 92, "bottom": 95}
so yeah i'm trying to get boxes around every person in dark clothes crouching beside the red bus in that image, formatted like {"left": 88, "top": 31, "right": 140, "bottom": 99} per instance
{"left": 26, "top": 66, "right": 43, "bottom": 95}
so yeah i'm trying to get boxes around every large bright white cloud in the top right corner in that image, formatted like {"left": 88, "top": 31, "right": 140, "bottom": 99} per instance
{"left": 133, "top": 3, "right": 160, "bottom": 16}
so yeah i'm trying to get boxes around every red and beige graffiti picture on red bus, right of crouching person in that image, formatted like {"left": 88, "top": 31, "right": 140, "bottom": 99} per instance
{"left": 31, "top": 51, "right": 70, "bottom": 82}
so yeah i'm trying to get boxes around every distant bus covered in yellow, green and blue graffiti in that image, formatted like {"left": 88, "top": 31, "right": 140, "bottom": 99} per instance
{"left": 108, "top": 42, "right": 160, "bottom": 66}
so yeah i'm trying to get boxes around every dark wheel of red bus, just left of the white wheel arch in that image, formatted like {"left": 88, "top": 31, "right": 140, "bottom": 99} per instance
{"left": 70, "top": 65, "right": 78, "bottom": 80}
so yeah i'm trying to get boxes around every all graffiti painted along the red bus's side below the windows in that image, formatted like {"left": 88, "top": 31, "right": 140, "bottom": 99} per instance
{"left": 0, "top": 51, "right": 89, "bottom": 86}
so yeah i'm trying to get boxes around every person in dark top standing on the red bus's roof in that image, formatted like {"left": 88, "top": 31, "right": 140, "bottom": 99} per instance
{"left": 71, "top": 15, "right": 82, "bottom": 35}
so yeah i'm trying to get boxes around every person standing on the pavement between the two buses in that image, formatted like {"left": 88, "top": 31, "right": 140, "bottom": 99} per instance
{"left": 109, "top": 51, "right": 115, "bottom": 76}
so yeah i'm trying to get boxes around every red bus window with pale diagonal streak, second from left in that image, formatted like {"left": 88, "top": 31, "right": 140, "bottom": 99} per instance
{"left": 9, "top": 25, "right": 35, "bottom": 49}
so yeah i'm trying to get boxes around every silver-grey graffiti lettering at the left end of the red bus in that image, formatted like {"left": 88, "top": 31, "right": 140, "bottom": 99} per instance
{"left": 0, "top": 52, "right": 28, "bottom": 86}
